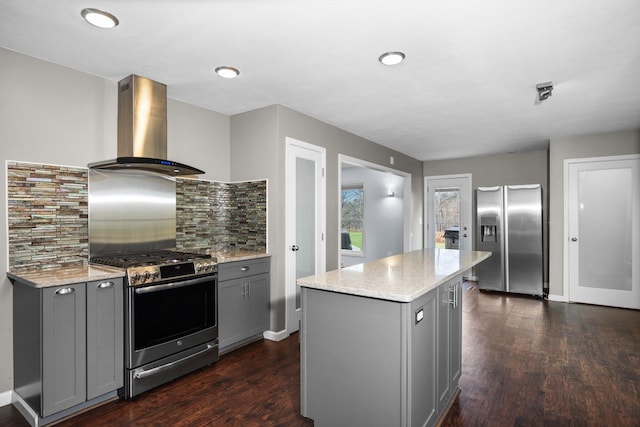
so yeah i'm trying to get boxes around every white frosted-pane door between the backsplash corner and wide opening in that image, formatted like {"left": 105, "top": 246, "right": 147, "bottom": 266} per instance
{"left": 285, "top": 138, "right": 326, "bottom": 333}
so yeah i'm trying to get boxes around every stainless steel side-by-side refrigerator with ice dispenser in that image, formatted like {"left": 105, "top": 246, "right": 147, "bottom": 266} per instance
{"left": 476, "top": 184, "right": 544, "bottom": 296}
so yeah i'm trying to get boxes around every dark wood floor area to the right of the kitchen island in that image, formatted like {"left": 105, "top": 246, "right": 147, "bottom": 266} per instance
{"left": 442, "top": 288, "right": 640, "bottom": 426}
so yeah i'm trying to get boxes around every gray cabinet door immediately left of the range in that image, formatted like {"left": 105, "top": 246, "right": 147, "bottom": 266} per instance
{"left": 87, "top": 279, "right": 124, "bottom": 399}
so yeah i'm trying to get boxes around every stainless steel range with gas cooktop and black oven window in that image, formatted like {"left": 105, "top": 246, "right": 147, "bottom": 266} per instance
{"left": 91, "top": 250, "right": 218, "bottom": 398}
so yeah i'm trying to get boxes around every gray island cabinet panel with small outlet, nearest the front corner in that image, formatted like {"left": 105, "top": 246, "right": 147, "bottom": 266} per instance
{"left": 407, "top": 290, "right": 438, "bottom": 426}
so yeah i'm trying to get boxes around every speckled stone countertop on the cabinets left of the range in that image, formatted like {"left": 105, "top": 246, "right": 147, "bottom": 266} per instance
{"left": 7, "top": 264, "right": 125, "bottom": 288}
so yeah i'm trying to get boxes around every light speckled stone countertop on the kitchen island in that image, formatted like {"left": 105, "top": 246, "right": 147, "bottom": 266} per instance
{"left": 297, "top": 249, "right": 491, "bottom": 302}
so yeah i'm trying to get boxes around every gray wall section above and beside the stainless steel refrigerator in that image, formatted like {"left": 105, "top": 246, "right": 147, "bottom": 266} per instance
{"left": 423, "top": 150, "right": 549, "bottom": 282}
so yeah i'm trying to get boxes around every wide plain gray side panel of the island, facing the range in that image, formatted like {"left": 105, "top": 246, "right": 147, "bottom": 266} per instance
{"left": 301, "top": 287, "right": 407, "bottom": 427}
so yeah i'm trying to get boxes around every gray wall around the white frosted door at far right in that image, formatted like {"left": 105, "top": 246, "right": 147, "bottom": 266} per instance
{"left": 549, "top": 130, "right": 640, "bottom": 299}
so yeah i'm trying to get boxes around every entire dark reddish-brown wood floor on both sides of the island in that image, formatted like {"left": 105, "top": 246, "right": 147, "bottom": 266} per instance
{"left": 0, "top": 288, "right": 640, "bottom": 427}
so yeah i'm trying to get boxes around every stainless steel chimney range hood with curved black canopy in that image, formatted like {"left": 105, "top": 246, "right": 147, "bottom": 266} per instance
{"left": 89, "top": 74, "right": 204, "bottom": 176}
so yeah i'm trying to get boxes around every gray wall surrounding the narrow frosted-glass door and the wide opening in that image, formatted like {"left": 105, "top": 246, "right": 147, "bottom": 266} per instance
{"left": 231, "top": 105, "right": 422, "bottom": 331}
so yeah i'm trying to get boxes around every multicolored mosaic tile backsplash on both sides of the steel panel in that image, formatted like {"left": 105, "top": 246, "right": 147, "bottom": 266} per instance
{"left": 7, "top": 162, "right": 267, "bottom": 269}
